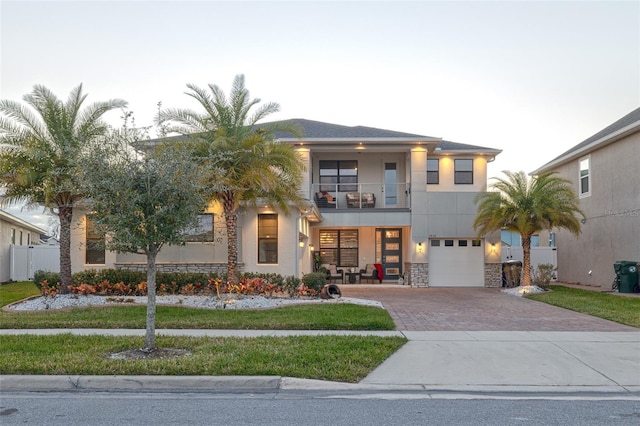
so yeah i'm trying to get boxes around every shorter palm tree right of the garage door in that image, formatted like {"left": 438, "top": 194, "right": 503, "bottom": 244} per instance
{"left": 473, "top": 171, "right": 585, "bottom": 286}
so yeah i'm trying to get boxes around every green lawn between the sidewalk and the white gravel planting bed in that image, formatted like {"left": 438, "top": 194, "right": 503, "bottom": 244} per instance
{"left": 0, "top": 282, "right": 395, "bottom": 330}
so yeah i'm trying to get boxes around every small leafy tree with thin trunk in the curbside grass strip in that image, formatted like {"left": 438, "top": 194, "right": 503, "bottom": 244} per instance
{"left": 82, "top": 126, "right": 206, "bottom": 351}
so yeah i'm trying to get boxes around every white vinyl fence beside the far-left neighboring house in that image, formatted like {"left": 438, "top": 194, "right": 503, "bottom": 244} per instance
{"left": 9, "top": 245, "right": 60, "bottom": 281}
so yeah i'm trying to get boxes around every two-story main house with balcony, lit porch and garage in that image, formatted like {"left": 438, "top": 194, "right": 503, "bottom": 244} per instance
{"left": 72, "top": 119, "right": 502, "bottom": 287}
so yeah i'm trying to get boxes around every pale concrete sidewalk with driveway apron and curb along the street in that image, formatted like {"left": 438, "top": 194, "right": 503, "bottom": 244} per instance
{"left": 0, "top": 329, "right": 640, "bottom": 401}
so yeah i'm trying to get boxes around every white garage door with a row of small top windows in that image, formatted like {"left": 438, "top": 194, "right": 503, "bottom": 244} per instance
{"left": 429, "top": 238, "right": 484, "bottom": 287}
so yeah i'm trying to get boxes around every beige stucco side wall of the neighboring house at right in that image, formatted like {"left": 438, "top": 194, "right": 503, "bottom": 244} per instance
{"left": 544, "top": 133, "right": 640, "bottom": 288}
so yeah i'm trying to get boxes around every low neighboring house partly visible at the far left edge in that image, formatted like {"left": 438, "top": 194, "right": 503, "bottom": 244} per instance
{"left": 0, "top": 210, "right": 46, "bottom": 283}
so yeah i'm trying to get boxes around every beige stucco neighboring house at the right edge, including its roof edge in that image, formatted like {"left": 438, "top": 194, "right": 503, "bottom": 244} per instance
{"left": 531, "top": 108, "right": 640, "bottom": 288}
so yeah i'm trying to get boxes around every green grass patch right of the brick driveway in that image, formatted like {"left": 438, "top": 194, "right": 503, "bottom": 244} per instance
{"left": 527, "top": 285, "right": 640, "bottom": 328}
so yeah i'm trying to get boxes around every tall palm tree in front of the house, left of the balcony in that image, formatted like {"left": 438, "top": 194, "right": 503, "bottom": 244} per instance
{"left": 157, "top": 74, "right": 304, "bottom": 284}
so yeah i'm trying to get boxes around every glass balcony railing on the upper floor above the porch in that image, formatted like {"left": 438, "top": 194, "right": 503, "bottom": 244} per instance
{"left": 311, "top": 183, "right": 410, "bottom": 211}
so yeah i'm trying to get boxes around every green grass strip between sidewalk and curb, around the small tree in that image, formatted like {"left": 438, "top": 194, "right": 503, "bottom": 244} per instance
{"left": 0, "top": 334, "right": 406, "bottom": 382}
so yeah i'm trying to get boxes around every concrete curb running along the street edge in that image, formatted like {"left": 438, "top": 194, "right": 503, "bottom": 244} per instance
{"left": 0, "top": 375, "right": 640, "bottom": 401}
